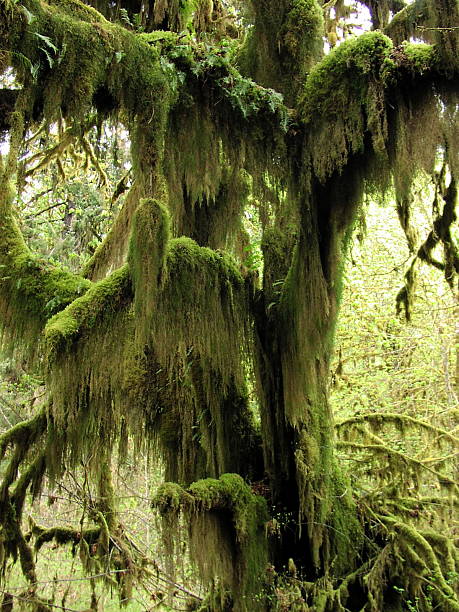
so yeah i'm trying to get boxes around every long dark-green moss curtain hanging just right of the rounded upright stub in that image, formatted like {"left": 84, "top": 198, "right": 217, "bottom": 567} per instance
{"left": 137, "top": 238, "right": 259, "bottom": 482}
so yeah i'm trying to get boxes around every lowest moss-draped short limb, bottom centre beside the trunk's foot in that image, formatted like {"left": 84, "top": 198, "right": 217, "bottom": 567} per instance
{"left": 153, "top": 474, "right": 268, "bottom": 612}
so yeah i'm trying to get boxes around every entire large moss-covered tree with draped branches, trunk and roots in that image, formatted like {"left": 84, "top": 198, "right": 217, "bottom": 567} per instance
{"left": 0, "top": 0, "right": 459, "bottom": 612}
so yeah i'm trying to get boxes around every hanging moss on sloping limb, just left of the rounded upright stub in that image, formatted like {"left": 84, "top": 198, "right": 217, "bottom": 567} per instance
{"left": 45, "top": 266, "right": 132, "bottom": 474}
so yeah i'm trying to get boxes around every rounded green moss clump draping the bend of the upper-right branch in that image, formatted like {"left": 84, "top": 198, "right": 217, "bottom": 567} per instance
{"left": 300, "top": 32, "right": 392, "bottom": 180}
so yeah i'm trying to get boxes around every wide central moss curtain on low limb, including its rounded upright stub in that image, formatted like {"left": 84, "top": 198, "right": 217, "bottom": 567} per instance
{"left": 45, "top": 222, "right": 258, "bottom": 482}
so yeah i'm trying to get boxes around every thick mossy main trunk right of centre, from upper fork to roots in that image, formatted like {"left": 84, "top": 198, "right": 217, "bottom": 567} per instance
{"left": 255, "top": 161, "right": 363, "bottom": 577}
